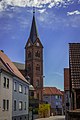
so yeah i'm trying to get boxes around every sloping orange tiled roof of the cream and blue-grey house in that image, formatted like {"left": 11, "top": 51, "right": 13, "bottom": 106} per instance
{"left": 0, "top": 50, "right": 28, "bottom": 83}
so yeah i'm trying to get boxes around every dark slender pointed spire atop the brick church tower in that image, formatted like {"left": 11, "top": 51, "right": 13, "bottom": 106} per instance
{"left": 29, "top": 8, "right": 38, "bottom": 43}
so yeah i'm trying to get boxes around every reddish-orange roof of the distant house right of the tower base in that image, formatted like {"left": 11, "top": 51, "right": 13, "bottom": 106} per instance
{"left": 43, "top": 87, "right": 63, "bottom": 95}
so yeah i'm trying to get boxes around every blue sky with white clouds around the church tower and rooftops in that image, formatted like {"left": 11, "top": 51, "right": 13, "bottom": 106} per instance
{"left": 0, "top": 0, "right": 80, "bottom": 90}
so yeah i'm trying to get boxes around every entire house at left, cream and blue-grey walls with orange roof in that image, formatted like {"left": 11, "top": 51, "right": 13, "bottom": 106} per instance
{"left": 0, "top": 51, "right": 29, "bottom": 120}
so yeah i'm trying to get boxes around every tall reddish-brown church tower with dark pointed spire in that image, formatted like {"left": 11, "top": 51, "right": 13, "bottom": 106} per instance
{"left": 25, "top": 10, "right": 43, "bottom": 100}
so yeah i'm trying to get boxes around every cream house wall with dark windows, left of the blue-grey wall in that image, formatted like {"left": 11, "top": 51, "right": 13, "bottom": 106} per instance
{"left": 0, "top": 71, "right": 13, "bottom": 120}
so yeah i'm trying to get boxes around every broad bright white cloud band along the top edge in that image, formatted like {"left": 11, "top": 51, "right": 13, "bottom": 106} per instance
{"left": 0, "top": 0, "right": 72, "bottom": 11}
